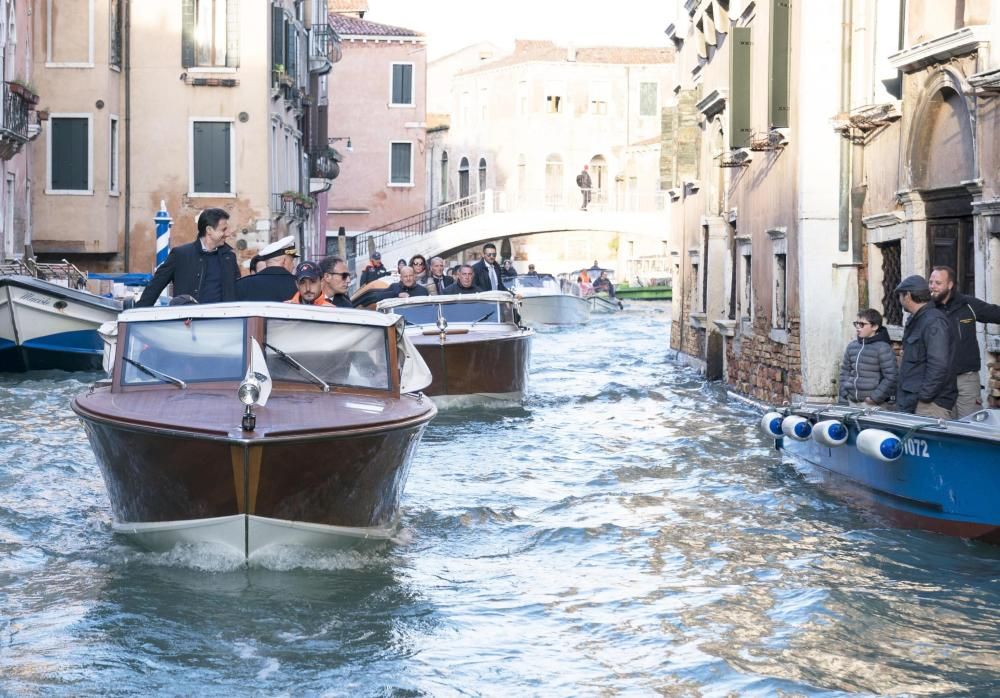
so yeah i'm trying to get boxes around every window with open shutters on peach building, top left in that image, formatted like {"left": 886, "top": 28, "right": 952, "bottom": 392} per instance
{"left": 181, "top": 0, "right": 239, "bottom": 68}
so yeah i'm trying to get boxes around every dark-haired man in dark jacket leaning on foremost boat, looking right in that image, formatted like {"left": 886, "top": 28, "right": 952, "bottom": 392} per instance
{"left": 135, "top": 208, "right": 240, "bottom": 308}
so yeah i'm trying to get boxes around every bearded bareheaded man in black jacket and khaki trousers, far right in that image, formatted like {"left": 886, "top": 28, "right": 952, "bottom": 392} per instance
{"left": 927, "top": 266, "right": 1000, "bottom": 419}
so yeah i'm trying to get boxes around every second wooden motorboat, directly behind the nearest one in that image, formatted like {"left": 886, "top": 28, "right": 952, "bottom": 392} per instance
{"left": 378, "top": 291, "right": 534, "bottom": 407}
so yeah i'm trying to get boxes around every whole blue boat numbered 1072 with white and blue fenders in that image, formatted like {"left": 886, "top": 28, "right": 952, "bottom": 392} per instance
{"left": 760, "top": 404, "right": 1000, "bottom": 544}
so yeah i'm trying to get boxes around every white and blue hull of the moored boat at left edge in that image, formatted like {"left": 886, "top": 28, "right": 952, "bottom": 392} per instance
{"left": 0, "top": 276, "right": 121, "bottom": 372}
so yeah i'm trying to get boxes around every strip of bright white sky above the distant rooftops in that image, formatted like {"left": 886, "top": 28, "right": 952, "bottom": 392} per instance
{"left": 365, "top": 0, "right": 677, "bottom": 60}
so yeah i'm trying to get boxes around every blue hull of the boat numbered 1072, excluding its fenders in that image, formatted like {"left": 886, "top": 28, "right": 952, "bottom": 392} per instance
{"left": 779, "top": 408, "right": 1000, "bottom": 543}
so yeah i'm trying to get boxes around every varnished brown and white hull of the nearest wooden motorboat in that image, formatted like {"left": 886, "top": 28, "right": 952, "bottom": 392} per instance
{"left": 74, "top": 403, "right": 433, "bottom": 556}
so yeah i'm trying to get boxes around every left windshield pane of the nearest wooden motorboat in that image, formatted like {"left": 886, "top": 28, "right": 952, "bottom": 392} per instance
{"left": 121, "top": 318, "right": 246, "bottom": 385}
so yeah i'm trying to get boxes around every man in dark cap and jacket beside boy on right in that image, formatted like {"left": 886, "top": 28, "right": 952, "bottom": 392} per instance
{"left": 896, "top": 275, "right": 958, "bottom": 419}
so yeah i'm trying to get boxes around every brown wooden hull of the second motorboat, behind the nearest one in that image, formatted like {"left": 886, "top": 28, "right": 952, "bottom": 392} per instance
{"left": 412, "top": 331, "right": 532, "bottom": 408}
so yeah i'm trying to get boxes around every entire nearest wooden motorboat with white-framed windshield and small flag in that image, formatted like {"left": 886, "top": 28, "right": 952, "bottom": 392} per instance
{"left": 72, "top": 303, "right": 437, "bottom": 556}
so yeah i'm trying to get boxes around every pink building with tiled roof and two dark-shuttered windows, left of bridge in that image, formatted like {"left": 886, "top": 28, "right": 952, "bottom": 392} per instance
{"left": 327, "top": 13, "right": 427, "bottom": 249}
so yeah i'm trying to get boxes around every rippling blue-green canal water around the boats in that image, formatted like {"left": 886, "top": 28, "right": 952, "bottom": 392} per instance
{"left": 0, "top": 302, "right": 1000, "bottom": 696}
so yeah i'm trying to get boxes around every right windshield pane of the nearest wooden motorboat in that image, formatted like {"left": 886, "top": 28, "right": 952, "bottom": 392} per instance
{"left": 264, "top": 319, "right": 392, "bottom": 390}
